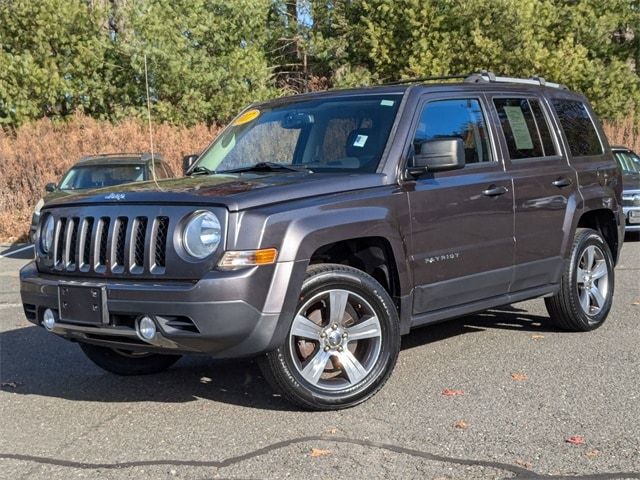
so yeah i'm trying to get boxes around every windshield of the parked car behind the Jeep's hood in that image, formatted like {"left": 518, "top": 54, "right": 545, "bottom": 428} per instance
{"left": 59, "top": 164, "right": 145, "bottom": 190}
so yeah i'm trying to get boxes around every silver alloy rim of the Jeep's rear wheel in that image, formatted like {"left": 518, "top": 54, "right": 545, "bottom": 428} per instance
{"left": 576, "top": 245, "right": 609, "bottom": 316}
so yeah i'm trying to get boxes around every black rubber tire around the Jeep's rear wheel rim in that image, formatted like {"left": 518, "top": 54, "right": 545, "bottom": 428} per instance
{"left": 545, "top": 228, "right": 614, "bottom": 332}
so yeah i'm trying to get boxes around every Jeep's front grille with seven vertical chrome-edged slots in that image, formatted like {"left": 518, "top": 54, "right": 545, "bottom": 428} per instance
{"left": 53, "top": 215, "right": 169, "bottom": 275}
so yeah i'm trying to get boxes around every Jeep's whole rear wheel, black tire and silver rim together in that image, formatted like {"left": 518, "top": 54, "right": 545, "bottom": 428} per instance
{"left": 545, "top": 228, "right": 614, "bottom": 332}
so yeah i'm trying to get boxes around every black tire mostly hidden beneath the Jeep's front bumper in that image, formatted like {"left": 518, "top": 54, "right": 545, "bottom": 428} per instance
{"left": 80, "top": 343, "right": 180, "bottom": 376}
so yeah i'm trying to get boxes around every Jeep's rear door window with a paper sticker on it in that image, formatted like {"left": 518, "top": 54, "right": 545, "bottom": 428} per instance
{"left": 493, "top": 98, "right": 557, "bottom": 159}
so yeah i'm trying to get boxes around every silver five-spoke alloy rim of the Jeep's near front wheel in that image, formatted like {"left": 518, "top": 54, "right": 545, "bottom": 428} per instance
{"left": 289, "top": 289, "right": 382, "bottom": 391}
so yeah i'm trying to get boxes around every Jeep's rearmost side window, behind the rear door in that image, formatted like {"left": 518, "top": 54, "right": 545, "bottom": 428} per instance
{"left": 553, "top": 99, "right": 603, "bottom": 157}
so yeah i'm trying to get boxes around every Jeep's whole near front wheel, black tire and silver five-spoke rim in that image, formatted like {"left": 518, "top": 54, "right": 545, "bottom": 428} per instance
{"left": 260, "top": 264, "right": 400, "bottom": 410}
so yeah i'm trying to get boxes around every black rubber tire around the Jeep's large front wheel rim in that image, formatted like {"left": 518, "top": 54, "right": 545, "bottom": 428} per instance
{"left": 258, "top": 264, "right": 400, "bottom": 410}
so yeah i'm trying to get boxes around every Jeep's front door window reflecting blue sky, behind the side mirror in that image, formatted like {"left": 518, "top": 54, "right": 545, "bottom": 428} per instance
{"left": 413, "top": 98, "right": 493, "bottom": 164}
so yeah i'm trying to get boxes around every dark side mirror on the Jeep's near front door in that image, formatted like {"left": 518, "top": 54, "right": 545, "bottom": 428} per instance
{"left": 409, "top": 138, "right": 465, "bottom": 175}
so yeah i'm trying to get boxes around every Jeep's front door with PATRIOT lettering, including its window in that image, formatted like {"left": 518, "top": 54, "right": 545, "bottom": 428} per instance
{"left": 405, "top": 96, "right": 514, "bottom": 314}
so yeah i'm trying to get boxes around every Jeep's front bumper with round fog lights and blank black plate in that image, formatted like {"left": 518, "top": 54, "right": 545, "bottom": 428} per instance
{"left": 20, "top": 262, "right": 305, "bottom": 358}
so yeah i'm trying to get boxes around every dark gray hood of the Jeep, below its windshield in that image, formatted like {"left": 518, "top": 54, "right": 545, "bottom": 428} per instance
{"left": 46, "top": 172, "right": 387, "bottom": 211}
